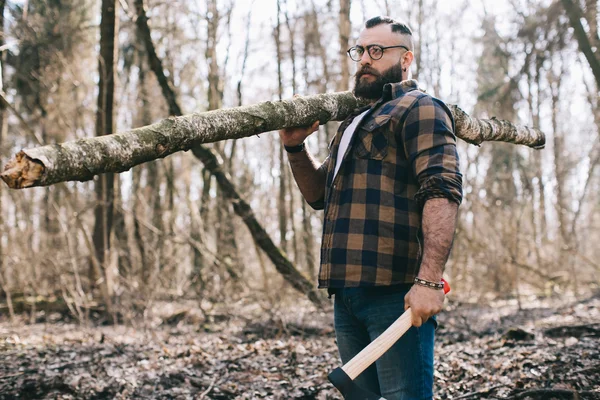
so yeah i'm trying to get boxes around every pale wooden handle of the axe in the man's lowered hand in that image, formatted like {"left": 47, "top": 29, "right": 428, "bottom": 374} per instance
{"left": 342, "top": 281, "right": 450, "bottom": 380}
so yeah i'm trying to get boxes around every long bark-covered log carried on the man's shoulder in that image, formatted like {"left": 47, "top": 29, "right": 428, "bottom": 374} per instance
{"left": 0, "top": 92, "right": 545, "bottom": 189}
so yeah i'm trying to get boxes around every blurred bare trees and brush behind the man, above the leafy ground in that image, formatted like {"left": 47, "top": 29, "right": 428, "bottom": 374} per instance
{"left": 0, "top": 0, "right": 600, "bottom": 321}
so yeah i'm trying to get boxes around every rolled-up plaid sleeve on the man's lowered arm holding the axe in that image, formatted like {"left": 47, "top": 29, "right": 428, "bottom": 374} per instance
{"left": 400, "top": 95, "right": 462, "bottom": 207}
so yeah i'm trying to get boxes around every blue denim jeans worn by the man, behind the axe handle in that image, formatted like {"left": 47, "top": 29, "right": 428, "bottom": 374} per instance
{"left": 334, "top": 287, "right": 437, "bottom": 400}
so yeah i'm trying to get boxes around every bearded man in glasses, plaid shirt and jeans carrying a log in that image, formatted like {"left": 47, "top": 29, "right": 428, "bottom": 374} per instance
{"left": 279, "top": 17, "right": 462, "bottom": 400}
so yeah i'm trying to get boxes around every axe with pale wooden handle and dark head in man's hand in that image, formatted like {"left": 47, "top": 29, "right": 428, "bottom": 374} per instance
{"left": 327, "top": 279, "right": 450, "bottom": 400}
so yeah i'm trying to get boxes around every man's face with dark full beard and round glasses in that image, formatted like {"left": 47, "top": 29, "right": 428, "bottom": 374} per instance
{"left": 353, "top": 24, "right": 410, "bottom": 100}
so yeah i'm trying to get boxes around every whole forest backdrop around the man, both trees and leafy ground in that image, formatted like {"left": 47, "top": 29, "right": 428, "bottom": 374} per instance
{"left": 0, "top": 0, "right": 600, "bottom": 400}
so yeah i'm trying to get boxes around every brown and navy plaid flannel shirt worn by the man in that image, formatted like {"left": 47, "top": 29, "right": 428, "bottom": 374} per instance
{"left": 311, "top": 80, "right": 462, "bottom": 288}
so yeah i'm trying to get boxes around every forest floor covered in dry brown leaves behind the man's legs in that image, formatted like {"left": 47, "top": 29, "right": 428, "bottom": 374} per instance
{"left": 0, "top": 293, "right": 600, "bottom": 399}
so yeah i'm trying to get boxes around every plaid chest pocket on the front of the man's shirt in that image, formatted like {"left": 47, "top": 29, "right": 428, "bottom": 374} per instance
{"left": 354, "top": 115, "right": 390, "bottom": 160}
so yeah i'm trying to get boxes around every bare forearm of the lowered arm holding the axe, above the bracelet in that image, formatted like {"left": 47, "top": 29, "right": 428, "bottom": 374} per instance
{"left": 418, "top": 198, "right": 458, "bottom": 282}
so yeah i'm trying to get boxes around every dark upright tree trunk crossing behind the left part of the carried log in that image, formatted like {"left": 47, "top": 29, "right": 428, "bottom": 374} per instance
{"left": 92, "top": 0, "right": 117, "bottom": 320}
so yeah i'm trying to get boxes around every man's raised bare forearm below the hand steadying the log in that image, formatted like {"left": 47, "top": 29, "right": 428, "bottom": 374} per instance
{"left": 288, "top": 147, "right": 326, "bottom": 203}
